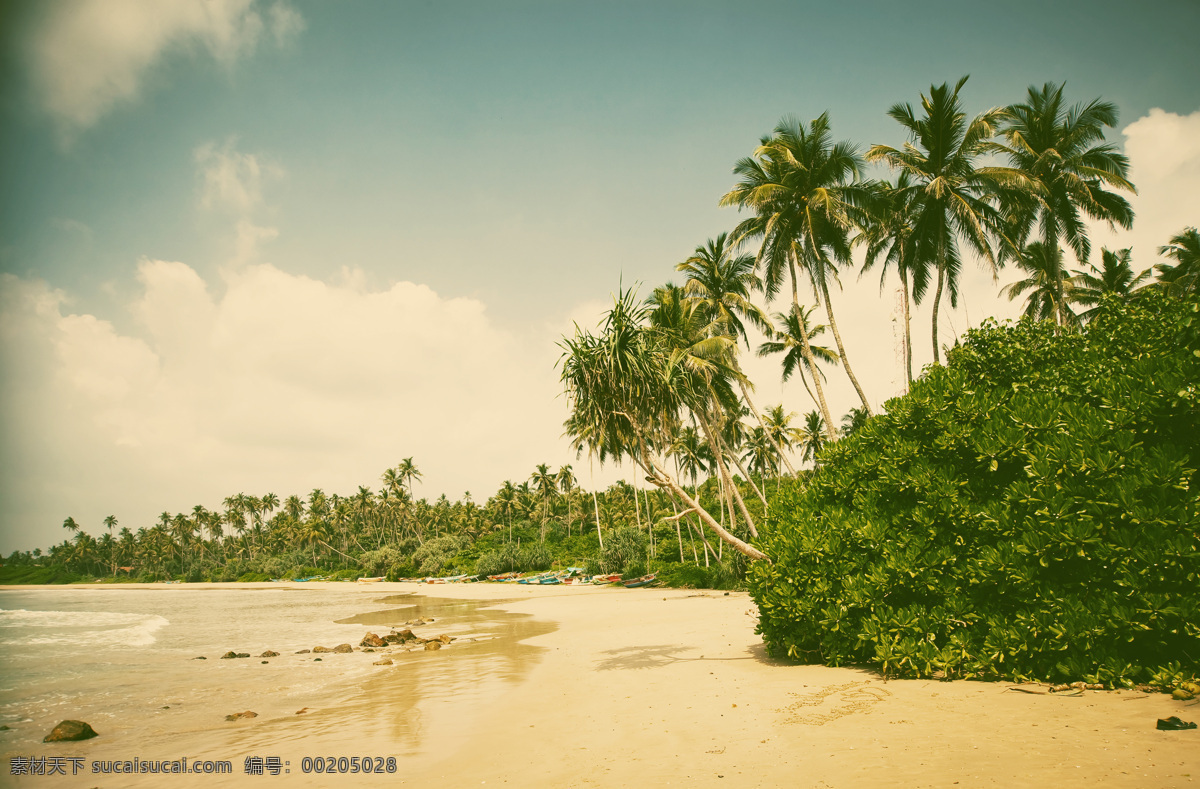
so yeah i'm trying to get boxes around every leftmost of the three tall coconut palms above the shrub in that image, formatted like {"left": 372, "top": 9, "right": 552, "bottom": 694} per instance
{"left": 720, "top": 114, "right": 870, "bottom": 426}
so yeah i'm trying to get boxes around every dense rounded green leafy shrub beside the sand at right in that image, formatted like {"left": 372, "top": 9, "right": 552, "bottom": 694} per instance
{"left": 749, "top": 295, "right": 1200, "bottom": 683}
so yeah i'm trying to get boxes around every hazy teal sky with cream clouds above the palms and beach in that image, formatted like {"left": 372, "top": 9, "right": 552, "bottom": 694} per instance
{"left": 0, "top": 0, "right": 1200, "bottom": 553}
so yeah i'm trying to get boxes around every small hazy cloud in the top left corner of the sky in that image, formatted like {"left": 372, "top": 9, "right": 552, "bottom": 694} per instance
{"left": 29, "top": 0, "right": 304, "bottom": 133}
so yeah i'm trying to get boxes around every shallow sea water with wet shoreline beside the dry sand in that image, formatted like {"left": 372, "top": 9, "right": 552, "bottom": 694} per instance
{"left": 0, "top": 584, "right": 552, "bottom": 787}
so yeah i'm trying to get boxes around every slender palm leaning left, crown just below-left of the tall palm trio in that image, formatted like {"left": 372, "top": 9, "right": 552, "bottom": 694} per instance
{"left": 676, "top": 233, "right": 796, "bottom": 474}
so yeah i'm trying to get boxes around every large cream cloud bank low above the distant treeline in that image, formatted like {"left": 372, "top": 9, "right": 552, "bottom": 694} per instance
{"left": 0, "top": 260, "right": 571, "bottom": 549}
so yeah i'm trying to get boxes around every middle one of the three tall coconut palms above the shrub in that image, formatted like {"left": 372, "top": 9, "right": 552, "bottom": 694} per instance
{"left": 864, "top": 77, "right": 1026, "bottom": 364}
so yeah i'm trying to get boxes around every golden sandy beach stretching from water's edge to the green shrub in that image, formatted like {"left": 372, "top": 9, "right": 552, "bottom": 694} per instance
{"left": 0, "top": 584, "right": 1200, "bottom": 787}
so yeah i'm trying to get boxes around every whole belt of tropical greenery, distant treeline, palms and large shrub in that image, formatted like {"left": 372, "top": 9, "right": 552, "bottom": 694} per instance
{"left": 0, "top": 77, "right": 1200, "bottom": 687}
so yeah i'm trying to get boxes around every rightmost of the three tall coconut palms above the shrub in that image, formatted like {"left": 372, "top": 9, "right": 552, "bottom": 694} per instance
{"left": 997, "top": 83, "right": 1136, "bottom": 327}
